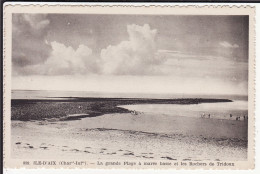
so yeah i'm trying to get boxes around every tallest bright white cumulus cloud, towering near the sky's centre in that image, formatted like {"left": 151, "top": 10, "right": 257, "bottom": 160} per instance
{"left": 100, "top": 24, "right": 165, "bottom": 75}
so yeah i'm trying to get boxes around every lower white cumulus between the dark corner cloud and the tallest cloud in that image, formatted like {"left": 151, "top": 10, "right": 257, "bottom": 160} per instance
{"left": 15, "top": 41, "right": 99, "bottom": 75}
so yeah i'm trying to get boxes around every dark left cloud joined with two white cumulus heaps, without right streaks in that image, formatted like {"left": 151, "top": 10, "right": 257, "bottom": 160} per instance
{"left": 13, "top": 18, "right": 165, "bottom": 75}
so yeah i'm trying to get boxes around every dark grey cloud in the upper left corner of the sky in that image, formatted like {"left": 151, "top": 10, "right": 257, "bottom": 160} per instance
{"left": 12, "top": 14, "right": 51, "bottom": 66}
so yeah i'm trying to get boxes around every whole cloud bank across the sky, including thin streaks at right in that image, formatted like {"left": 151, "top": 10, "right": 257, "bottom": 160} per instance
{"left": 12, "top": 14, "right": 244, "bottom": 81}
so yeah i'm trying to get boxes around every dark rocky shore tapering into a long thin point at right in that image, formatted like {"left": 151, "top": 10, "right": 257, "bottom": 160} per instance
{"left": 11, "top": 97, "right": 232, "bottom": 121}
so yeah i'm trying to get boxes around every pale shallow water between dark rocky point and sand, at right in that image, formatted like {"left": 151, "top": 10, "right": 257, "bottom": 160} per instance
{"left": 119, "top": 100, "right": 248, "bottom": 120}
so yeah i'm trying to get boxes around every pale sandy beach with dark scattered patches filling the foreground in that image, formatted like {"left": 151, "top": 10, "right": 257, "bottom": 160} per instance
{"left": 11, "top": 109, "right": 247, "bottom": 161}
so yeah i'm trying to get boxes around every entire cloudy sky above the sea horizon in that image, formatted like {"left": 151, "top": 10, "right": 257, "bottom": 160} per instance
{"left": 12, "top": 14, "right": 248, "bottom": 95}
